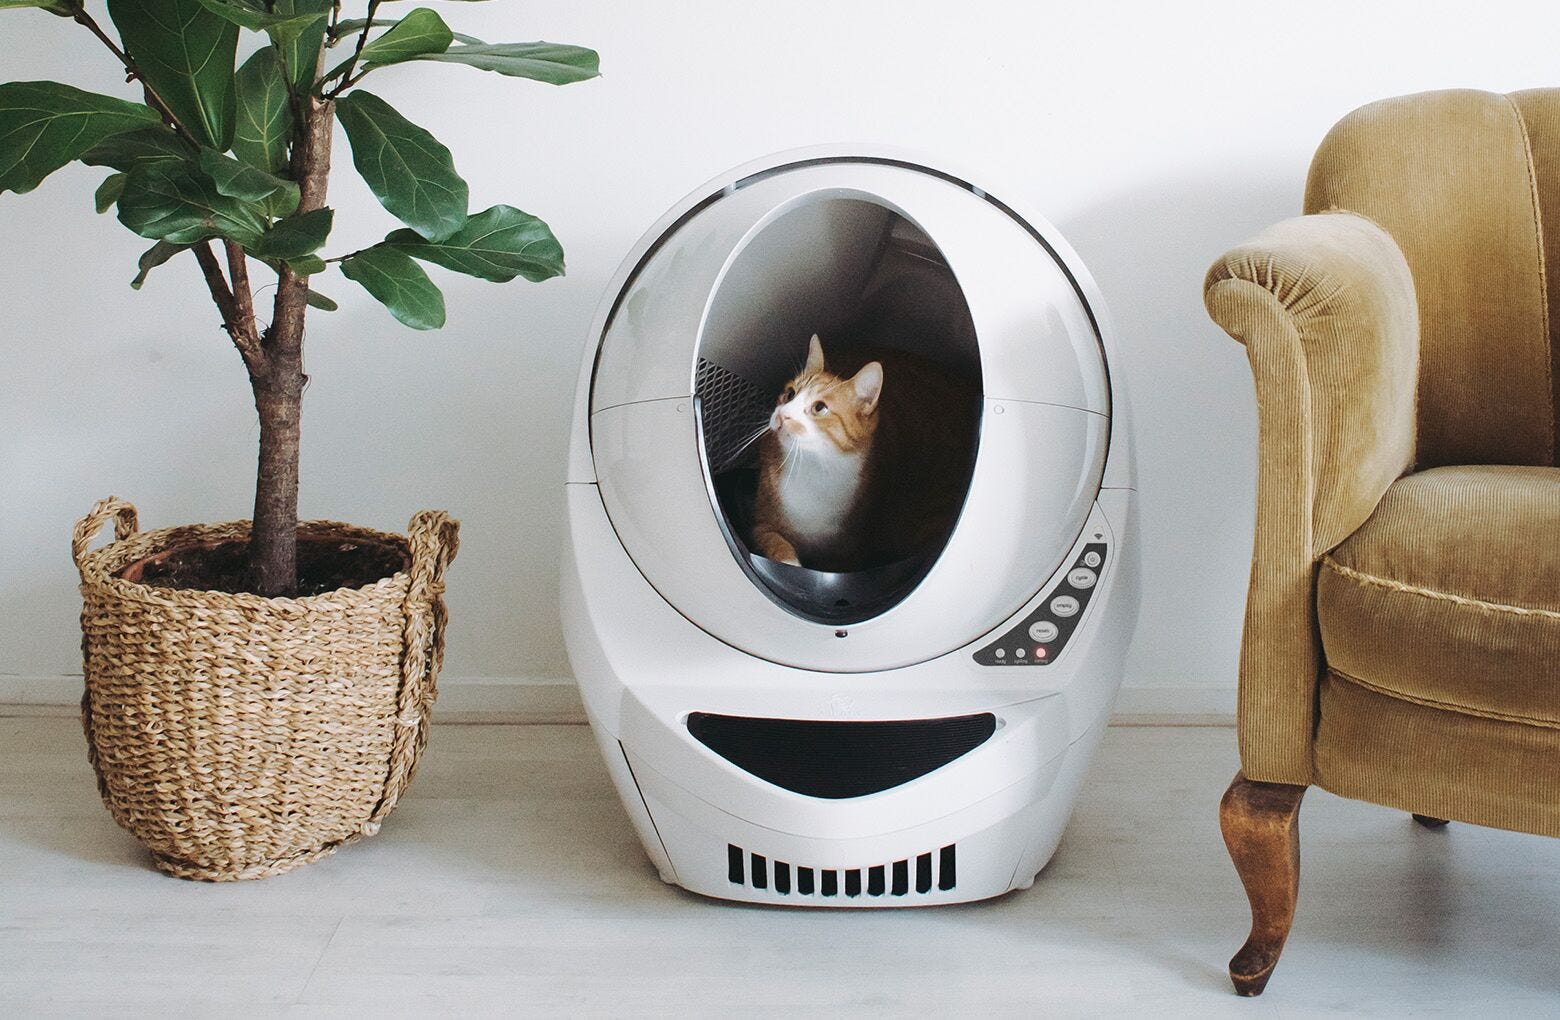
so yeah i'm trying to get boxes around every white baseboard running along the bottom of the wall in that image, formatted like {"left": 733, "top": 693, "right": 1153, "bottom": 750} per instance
{"left": 0, "top": 674, "right": 1236, "bottom": 725}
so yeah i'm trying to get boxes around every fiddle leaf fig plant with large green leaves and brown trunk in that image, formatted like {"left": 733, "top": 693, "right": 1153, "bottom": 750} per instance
{"left": 0, "top": 0, "right": 599, "bottom": 596}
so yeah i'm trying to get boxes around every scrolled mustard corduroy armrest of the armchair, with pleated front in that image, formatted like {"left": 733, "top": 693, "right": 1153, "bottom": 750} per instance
{"left": 1203, "top": 212, "right": 1420, "bottom": 783}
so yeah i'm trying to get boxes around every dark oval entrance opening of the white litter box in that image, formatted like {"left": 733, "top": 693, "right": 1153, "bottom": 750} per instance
{"left": 694, "top": 195, "right": 981, "bottom": 624}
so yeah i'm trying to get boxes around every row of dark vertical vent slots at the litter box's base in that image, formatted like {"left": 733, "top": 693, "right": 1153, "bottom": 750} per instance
{"left": 725, "top": 844, "right": 958, "bottom": 900}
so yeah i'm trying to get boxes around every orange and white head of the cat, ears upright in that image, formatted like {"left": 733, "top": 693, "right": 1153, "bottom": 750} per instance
{"left": 769, "top": 334, "right": 883, "bottom": 454}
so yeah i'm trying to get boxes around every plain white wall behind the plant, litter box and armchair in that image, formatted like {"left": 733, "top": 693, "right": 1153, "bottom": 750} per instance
{"left": 0, "top": 0, "right": 1560, "bottom": 707}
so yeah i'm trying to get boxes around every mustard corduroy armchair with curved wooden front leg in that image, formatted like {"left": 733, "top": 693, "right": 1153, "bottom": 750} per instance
{"left": 1204, "top": 89, "right": 1560, "bottom": 995}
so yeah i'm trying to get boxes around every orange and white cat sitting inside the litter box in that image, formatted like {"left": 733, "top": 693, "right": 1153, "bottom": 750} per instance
{"left": 753, "top": 335, "right": 980, "bottom": 571}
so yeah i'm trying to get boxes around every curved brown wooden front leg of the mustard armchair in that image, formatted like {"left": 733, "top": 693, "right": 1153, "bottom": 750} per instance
{"left": 1218, "top": 772, "right": 1306, "bottom": 995}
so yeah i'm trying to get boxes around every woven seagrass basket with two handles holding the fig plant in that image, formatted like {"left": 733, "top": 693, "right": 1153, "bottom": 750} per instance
{"left": 72, "top": 498, "right": 459, "bottom": 881}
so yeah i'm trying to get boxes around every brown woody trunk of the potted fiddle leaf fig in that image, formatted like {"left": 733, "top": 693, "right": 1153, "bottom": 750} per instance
{"left": 250, "top": 97, "right": 335, "bottom": 597}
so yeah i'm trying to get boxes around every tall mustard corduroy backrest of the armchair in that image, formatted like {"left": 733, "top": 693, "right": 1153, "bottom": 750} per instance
{"left": 1306, "top": 89, "right": 1560, "bottom": 469}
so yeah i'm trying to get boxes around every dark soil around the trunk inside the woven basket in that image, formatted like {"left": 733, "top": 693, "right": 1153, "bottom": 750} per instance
{"left": 120, "top": 537, "right": 409, "bottom": 596}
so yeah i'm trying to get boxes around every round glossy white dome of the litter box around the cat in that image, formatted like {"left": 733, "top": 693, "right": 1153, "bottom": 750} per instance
{"left": 588, "top": 156, "right": 1111, "bottom": 672}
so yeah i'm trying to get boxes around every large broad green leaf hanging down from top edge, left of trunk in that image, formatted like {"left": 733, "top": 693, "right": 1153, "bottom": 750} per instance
{"left": 108, "top": 0, "right": 239, "bottom": 151}
